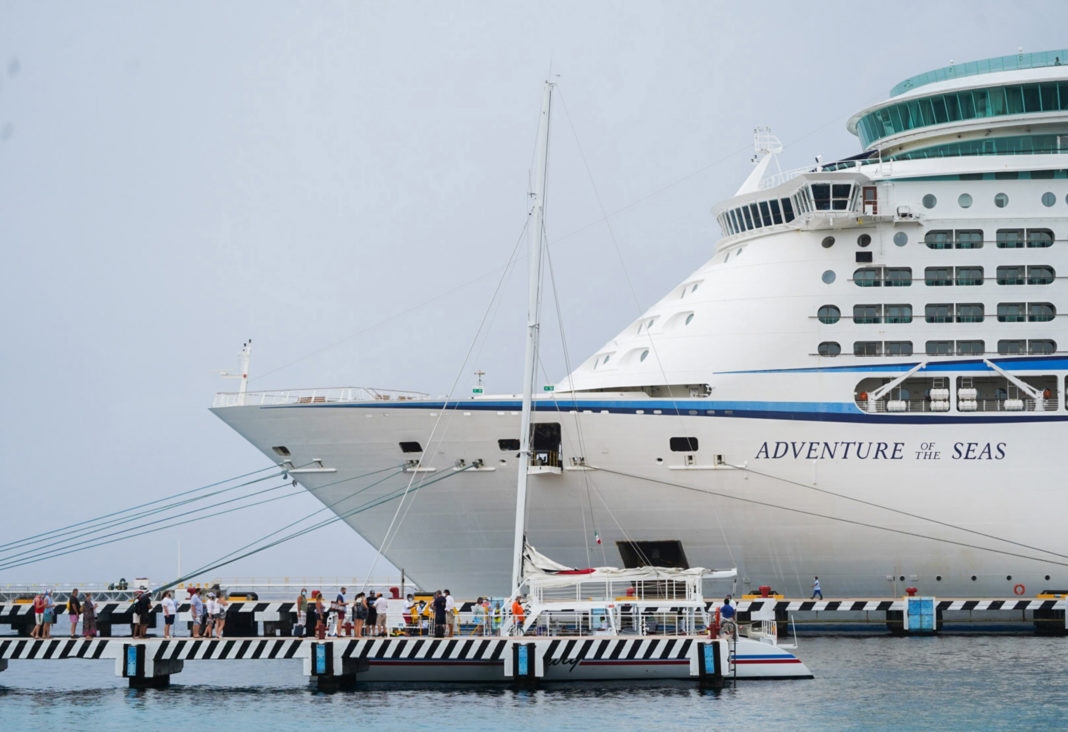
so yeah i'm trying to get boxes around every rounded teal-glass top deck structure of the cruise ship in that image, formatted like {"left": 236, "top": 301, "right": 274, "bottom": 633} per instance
{"left": 847, "top": 49, "right": 1068, "bottom": 160}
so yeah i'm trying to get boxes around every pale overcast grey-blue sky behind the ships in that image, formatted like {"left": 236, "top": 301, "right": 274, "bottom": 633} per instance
{"left": 0, "top": 0, "right": 1068, "bottom": 583}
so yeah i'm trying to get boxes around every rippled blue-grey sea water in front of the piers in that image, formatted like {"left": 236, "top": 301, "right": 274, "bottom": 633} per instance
{"left": 0, "top": 635, "right": 1068, "bottom": 732}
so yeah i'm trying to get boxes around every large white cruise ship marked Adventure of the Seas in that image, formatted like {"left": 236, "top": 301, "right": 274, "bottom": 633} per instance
{"left": 213, "top": 49, "right": 1068, "bottom": 597}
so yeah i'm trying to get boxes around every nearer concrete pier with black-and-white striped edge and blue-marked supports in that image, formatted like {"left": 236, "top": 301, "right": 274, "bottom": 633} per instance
{"left": 0, "top": 636, "right": 729, "bottom": 690}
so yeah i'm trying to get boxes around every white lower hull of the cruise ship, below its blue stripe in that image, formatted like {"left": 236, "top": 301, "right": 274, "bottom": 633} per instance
{"left": 216, "top": 391, "right": 1068, "bottom": 597}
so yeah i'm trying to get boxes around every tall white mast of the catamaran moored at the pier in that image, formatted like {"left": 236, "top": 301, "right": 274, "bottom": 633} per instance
{"left": 512, "top": 81, "right": 552, "bottom": 596}
